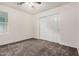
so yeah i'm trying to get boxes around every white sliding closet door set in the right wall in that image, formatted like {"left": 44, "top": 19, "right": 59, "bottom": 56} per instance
{"left": 39, "top": 15, "right": 60, "bottom": 42}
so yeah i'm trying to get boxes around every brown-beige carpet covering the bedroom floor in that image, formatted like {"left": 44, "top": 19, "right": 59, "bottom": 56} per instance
{"left": 0, "top": 38, "right": 78, "bottom": 56}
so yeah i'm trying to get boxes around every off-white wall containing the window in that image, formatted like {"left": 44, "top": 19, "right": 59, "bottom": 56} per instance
{"left": 0, "top": 5, "right": 33, "bottom": 45}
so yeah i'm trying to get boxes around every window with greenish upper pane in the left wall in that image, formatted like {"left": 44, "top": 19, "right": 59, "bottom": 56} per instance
{"left": 0, "top": 11, "right": 8, "bottom": 33}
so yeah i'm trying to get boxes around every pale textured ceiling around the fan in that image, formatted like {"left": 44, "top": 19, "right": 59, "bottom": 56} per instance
{"left": 0, "top": 2, "right": 68, "bottom": 14}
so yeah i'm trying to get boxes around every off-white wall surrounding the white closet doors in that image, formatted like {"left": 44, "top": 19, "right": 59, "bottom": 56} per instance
{"left": 34, "top": 3, "right": 78, "bottom": 47}
